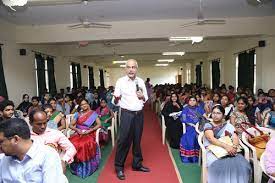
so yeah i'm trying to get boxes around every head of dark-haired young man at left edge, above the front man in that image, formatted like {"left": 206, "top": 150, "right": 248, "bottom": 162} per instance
{"left": 0, "top": 100, "right": 14, "bottom": 121}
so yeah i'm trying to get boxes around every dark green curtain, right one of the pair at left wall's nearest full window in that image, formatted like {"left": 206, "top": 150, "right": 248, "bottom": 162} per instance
{"left": 47, "top": 57, "right": 57, "bottom": 96}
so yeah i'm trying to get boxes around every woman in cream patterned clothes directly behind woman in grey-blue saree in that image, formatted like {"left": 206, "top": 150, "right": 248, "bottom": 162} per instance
{"left": 230, "top": 97, "right": 250, "bottom": 138}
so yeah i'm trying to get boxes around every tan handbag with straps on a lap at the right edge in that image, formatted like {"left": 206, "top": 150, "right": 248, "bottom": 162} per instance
{"left": 243, "top": 122, "right": 270, "bottom": 159}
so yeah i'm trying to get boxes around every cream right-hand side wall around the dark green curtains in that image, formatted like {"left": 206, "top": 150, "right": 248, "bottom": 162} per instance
{"left": 208, "top": 36, "right": 275, "bottom": 91}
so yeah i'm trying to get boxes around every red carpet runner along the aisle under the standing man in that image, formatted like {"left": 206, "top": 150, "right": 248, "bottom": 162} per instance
{"left": 98, "top": 106, "right": 179, "bottom": 183}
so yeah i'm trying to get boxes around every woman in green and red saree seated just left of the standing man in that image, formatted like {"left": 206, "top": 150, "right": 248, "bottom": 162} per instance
{"left": 96, "top": 99, "right": 114, "bottom": 143}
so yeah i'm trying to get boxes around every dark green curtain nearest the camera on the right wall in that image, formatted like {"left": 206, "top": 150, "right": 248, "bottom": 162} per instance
{"left": 238, "top": 50, "right": 255, "bottom": 91}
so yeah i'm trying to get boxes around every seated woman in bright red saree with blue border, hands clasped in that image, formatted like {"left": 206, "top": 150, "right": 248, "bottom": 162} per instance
{"left": 70, "top": 99, "right": 101, "bottom": 178}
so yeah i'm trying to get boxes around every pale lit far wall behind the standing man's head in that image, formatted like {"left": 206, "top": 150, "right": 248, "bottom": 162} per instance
{"left": 106, "top": 67, "right": 179, "bottom": 86}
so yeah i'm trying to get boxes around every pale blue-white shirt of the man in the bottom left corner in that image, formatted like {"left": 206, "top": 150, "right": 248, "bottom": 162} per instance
{"left": 0, "top": 142, "right": 65, "bottom": 183}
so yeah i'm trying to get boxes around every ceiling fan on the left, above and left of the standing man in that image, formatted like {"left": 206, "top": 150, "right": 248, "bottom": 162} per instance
{"left": 68, "top": 18, "right": 112, "bottom": 29}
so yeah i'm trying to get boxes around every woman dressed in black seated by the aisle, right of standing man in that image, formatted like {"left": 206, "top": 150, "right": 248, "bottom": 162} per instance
{"left": 161, "top": 93, "right": 182, "bottom": 149}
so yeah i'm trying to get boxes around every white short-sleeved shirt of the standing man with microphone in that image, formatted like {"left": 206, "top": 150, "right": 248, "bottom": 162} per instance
{"left": 114, "top": 76, "right": 148, "bottom": 111}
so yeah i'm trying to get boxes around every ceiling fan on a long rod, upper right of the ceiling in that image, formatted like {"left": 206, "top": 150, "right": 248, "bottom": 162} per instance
{"left": 181, "top": 0, "right": 226, "bottom": 27}
